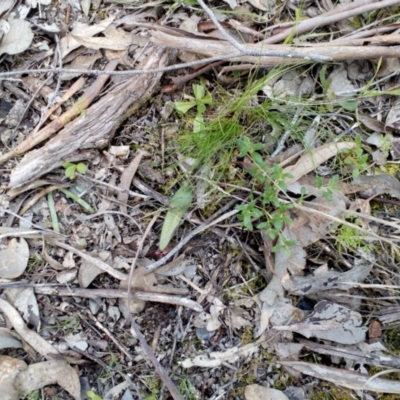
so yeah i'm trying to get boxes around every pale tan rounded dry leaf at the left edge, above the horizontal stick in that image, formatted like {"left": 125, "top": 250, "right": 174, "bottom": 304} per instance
{"left": 0, "top": 238, "right": 29, "bottom": 279}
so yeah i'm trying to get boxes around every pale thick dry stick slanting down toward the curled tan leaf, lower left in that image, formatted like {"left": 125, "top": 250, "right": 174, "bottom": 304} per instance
{"left": 0, "top": 299, "right": 60, "bottom": 360}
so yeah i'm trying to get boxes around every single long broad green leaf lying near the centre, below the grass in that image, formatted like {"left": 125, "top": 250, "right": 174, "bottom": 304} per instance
{"left": 159, "top": 184, "right": 193, "bottom": 250}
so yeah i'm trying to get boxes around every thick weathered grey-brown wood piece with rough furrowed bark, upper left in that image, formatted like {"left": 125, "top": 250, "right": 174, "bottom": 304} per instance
{"left": 10, "top": 46, "right": 170, "bottom": 187}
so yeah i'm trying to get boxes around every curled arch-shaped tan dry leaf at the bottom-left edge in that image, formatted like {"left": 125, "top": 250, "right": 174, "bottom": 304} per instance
{"left": 14, "top": 360, "right": 81, "bottom": 400}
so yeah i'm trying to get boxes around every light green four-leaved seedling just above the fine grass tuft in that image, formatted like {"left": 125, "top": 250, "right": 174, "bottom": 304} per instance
{"left": 174, "top": 81, "right": 213, "bottom": 132}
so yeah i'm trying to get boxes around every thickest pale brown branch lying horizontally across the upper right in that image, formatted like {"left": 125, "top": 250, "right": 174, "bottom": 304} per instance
{"left": 152, "top": 31, "right": 400, "bottom": 66}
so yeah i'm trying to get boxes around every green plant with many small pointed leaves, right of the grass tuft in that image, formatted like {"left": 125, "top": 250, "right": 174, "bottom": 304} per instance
{"left": 237, "top": 136, "right": 294, "bottom": 251}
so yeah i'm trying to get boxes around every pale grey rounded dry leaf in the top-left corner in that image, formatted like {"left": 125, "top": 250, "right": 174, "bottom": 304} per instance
{"left": 0, "top": 19, "right": 33, "bottom": 55}
